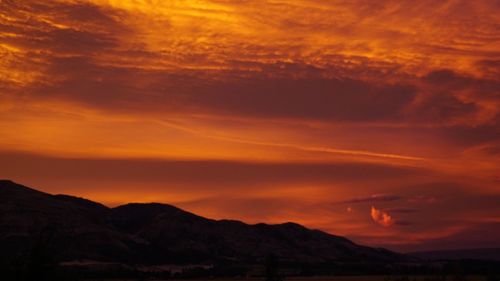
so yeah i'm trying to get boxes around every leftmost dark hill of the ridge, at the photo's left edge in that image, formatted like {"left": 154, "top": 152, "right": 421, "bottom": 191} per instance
{"left": 0, "top": 181, "right": 145, "bottom": 260}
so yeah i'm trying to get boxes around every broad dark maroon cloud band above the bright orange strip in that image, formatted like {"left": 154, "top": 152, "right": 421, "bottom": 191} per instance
{"left": 19, "top": 57, "right": 415, "bottom": 122}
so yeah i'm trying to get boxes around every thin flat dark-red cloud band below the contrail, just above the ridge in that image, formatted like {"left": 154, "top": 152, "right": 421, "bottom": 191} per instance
{"left": 0, "top": 150, "right": 426, "bottom": 187}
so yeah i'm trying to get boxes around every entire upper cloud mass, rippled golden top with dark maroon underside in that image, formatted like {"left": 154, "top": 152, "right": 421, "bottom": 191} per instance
{"left": 0, "top": 1, "right": 500, "bottom": 125}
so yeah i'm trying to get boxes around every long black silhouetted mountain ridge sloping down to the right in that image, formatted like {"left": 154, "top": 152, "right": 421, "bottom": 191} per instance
{"left": 0, "top": 180, "right": 409, "bottom": 264}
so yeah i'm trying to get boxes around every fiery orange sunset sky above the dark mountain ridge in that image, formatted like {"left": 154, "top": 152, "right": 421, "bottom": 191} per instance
{"left": 0, "top": 0, "right": 500, "bottom": 252}
